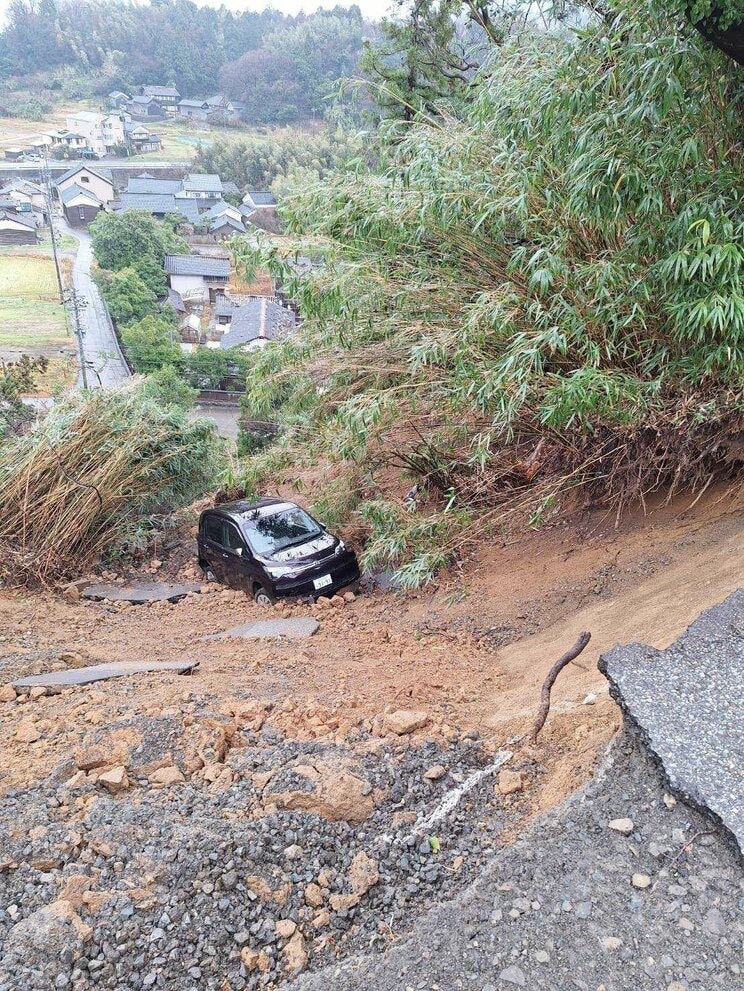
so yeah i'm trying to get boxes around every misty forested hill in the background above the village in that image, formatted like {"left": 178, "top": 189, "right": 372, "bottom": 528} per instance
{"left": 0, "top": 0, "right": 365, "bottom": 122}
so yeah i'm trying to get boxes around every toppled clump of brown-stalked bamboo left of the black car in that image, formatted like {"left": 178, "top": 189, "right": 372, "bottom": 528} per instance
{"left": 0, "top": 386, "right": 220, "bottom": 582}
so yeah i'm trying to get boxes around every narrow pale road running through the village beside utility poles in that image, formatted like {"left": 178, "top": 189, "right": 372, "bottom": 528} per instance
{"left": 54, "top": 217, "right": 130, "bottom": 389}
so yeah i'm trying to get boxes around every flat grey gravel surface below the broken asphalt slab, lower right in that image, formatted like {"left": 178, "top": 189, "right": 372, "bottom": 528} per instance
{"left": 293, "top": 730, "right": 744, "bottom": 991}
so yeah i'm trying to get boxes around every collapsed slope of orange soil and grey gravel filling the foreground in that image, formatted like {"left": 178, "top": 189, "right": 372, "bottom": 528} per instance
{"left": 0, "top": 493, "right": 744, "bottom": 991}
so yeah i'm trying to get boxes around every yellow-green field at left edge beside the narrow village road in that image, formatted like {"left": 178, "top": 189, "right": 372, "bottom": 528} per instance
{"left": 0, "top": 255, "right": 70, "bottom": 349}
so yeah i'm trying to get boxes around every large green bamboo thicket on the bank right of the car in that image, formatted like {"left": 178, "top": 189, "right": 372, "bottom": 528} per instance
{"left": 236, "top": 3, "right": 744, "bottom": 584}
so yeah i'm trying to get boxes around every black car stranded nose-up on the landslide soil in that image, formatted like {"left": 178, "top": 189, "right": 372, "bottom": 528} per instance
{"left": 198, "top": 499, "right": 359, "bottom": 605}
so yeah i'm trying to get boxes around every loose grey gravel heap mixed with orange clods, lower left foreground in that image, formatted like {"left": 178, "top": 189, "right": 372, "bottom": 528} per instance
{"left": 0, "top": 716, "right": 527, "bottom": 991}
